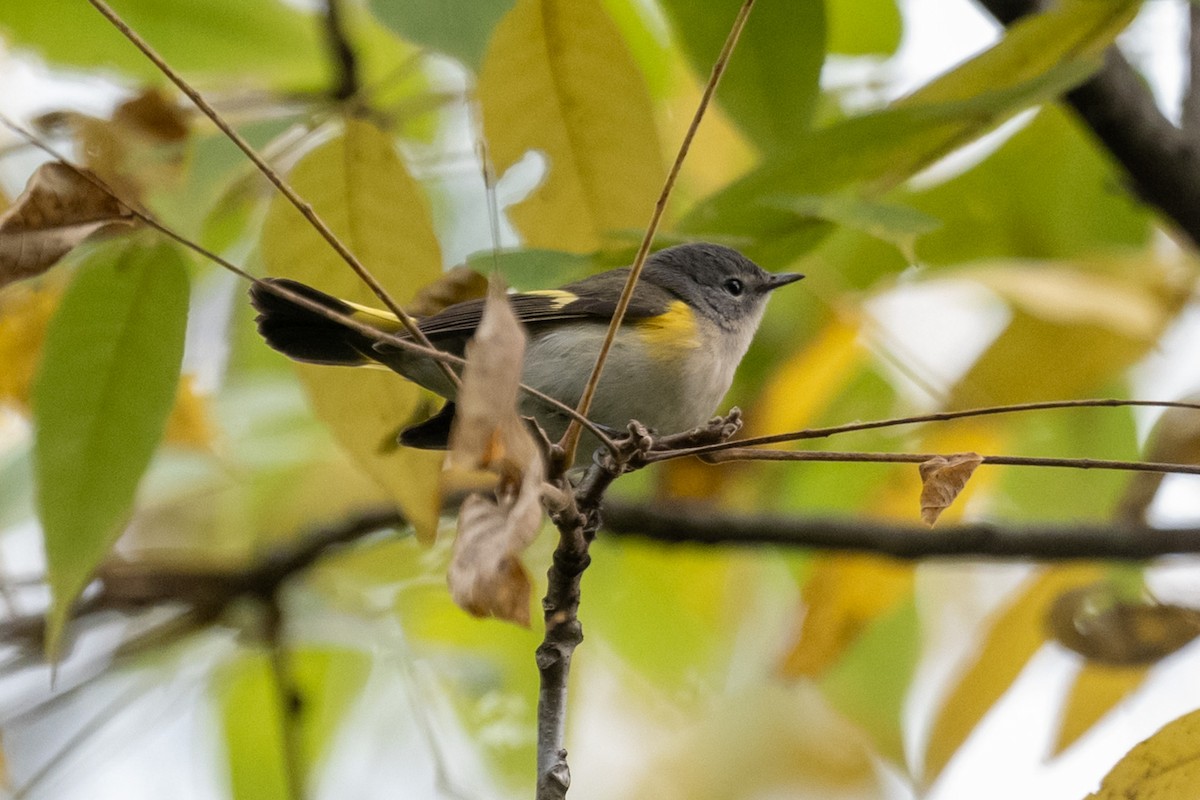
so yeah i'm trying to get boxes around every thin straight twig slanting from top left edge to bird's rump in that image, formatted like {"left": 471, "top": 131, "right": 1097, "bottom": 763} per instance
{"left": 88, "top": 0, "right": 458, "bottom": 386}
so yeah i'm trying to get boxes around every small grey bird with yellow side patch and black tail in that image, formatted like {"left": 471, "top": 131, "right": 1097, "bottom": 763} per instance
{"left": 251, "top": 243, "right": 804, "bottom": 452}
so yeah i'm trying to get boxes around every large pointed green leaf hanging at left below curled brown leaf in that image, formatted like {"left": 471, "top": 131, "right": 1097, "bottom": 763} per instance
{"left": 34, "top": 242, "right": 188, "bottom": 654}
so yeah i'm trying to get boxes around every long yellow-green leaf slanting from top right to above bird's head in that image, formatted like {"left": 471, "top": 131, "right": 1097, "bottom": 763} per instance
{"left": 680, "top": 0, "right": 1139, "bottom": 264}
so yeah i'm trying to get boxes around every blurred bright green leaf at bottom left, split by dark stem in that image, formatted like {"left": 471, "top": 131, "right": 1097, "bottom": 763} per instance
{"left": 216, "top": 648, "right": 371, "bottom": 800}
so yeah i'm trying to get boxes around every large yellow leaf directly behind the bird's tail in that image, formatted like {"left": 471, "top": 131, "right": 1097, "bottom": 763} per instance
{"left": 262, "top": 120, "right": 442, "bottom": 542}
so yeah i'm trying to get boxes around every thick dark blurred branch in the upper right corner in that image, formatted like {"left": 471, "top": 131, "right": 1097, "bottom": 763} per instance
{"left": 978, "top": 0, "right": 1200, "bottom": 246}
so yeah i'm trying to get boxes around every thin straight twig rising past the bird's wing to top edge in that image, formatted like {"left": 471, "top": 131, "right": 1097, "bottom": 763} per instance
{"left": 559, "top": 0, "right": 755, "bottom": 464}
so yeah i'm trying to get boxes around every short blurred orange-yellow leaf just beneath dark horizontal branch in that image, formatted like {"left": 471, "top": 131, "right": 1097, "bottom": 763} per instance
{"left": 780, "top": 555, "right": 913, "bottom": 678}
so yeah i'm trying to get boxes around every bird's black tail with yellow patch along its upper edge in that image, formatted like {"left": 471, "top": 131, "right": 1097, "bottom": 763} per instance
{"left": 250, "top": 278, "right": 401, "bottom": 367}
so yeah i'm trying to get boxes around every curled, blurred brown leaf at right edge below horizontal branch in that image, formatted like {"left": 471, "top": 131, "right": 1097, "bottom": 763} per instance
{"left": 1046, "top": 583, "right": 1200, "bottom": 666}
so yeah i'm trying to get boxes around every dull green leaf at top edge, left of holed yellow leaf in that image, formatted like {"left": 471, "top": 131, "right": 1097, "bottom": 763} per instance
{"left": 371, "top": 0, "right": 514, "bottom": 71}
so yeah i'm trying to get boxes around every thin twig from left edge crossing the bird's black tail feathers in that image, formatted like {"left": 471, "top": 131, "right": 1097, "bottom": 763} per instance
{"left": 0, "top": 114, "right": 617, "bottom": 460}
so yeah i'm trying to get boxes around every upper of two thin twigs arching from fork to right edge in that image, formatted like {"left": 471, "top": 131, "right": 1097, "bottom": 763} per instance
{"left": 647, "top": 398, "right": 1200, "bottom": 462}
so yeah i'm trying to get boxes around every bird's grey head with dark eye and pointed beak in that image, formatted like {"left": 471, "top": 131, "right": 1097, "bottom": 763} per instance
{"left": 643, "top": 242, "right": 804, "bottom": 330}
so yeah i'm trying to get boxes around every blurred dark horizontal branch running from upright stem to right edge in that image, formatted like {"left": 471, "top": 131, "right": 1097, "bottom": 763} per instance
{"left": 604, "top": 501, "right": 1200, "bottom": 561}
